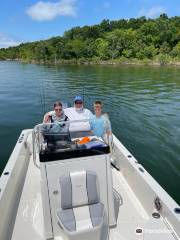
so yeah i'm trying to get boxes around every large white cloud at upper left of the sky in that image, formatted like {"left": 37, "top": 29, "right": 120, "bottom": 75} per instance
{"left": 26, "top": 0, "right": 76, "bottom": 21}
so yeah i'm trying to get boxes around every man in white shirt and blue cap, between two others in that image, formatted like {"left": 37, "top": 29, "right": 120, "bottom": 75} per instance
{"left": 64, "top": 96, "right": 93, "bottom": 131}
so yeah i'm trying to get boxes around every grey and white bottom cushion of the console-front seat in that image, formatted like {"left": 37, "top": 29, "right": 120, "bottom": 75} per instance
{"left": 57, "top": 203, "right": 104, "bottom": 232}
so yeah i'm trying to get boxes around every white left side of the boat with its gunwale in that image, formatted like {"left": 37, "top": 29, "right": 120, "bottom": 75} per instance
{"left": 0, "top": 129, "right": 32, "bottom": 240}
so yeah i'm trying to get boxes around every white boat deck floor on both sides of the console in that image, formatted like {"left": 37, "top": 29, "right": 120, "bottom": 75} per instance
{"left": 12, "top": 157, "right": 178, "bottom": 240}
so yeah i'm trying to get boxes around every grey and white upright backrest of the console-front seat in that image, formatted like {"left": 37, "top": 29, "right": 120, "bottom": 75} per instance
{"left": 60, "top": 171, "right": 99, "bottom": 209}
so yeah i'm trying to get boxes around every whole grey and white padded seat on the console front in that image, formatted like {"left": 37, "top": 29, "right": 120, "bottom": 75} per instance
{"left": 57, "top": 171, "right": 105, "bottom": 240}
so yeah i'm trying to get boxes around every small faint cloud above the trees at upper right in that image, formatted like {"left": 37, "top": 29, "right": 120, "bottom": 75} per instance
{"left": 138, "top": 6, "right": 166, "bottom": 18}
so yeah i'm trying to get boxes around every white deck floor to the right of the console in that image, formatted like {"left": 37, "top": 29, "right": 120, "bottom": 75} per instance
{"left": 110, "top": 169, "right": 176, "bottom": 240}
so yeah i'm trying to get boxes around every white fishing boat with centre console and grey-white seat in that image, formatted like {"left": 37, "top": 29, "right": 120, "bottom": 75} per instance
{"left": 0, "top": 118, "right": 180, "bottom": 240}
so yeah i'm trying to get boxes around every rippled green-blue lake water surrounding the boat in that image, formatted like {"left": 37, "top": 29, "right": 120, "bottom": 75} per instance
{"left": 0, "top": 62, "right": 180, "bottom": 204}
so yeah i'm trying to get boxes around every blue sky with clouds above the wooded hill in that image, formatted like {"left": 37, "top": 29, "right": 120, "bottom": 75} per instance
{"left": 0, "top": 0, "right": 180, "bottom": 48}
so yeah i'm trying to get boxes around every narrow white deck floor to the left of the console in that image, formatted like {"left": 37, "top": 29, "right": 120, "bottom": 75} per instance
{"left": 12, "top": 157, "right": 44, "bottom": 240}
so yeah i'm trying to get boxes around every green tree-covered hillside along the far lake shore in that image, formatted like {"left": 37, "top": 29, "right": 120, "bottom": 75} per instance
{"left": 0, "top": 14, "right": 180, "bottom": 65}
